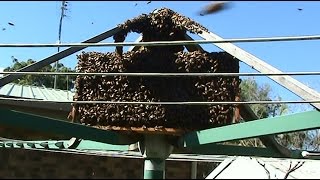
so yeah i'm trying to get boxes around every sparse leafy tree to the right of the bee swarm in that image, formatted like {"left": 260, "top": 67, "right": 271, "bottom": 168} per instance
{"left": 226, "top": 78, "right": 320, "bottom": 150}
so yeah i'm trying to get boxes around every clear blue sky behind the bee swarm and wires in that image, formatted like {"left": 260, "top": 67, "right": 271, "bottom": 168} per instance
{"left": 0, "top": 1, "right": 320, "bottom": 112}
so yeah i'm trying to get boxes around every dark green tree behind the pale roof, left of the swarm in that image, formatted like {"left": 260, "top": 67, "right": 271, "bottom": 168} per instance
{"left": 3, "top": 59, "right": 75, "bottom": 90}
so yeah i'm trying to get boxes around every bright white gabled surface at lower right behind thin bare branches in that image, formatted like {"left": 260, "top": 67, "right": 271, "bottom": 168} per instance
{"left": 208, "top": 157, "right": 320, "bottom": 179}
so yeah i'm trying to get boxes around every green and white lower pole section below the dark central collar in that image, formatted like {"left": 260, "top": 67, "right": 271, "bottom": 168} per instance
{"left": 143, "top": 158, "right": 166, "bottom": 179}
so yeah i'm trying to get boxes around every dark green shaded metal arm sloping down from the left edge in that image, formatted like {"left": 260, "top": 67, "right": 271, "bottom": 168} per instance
{"left": 0, "top": 109, "right": 139, "bottom": 145}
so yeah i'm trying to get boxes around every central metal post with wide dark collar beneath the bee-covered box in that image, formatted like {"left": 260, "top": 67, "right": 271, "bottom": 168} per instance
{"left": 139, "top": 135, "right": 173, "bottom": 179}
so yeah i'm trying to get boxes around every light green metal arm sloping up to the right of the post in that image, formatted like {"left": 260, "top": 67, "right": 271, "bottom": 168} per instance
{"left": 180, "top": 111, "right": 320, "bottom": 147}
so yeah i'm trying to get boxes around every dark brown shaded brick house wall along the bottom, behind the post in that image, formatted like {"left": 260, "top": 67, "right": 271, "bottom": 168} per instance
{"left": 0, "top": 149, "right": 212, "bottom": 179}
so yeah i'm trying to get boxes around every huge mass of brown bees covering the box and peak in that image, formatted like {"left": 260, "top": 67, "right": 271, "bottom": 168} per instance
{"left": 73, "top": 9, "right": 240, "bottom": 130}
